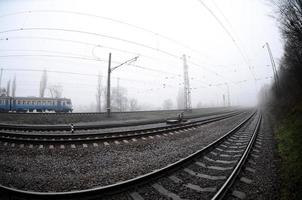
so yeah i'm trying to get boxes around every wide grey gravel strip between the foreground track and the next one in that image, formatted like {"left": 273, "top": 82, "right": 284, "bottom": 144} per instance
{"left": 0, "top": 113, "right": 250, "bottom": 192}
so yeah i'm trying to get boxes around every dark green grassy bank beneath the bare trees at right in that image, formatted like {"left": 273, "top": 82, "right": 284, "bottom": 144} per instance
{"left": 276, "top": 103, "right": 302, "bottom": 200}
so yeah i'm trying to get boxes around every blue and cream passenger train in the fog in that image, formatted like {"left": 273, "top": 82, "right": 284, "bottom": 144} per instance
{"left": 0, "top": 96, "right": 72, "bottom": 113}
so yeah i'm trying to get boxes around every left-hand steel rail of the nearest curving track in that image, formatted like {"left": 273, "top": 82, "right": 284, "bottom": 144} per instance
{"left": 0, "top": 112, "right": 256, "bottom": 200}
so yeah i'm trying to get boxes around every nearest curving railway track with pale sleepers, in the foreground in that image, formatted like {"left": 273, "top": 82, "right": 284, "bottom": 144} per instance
{"left": 0, "top": 110, "right": 261, "bottom": 200}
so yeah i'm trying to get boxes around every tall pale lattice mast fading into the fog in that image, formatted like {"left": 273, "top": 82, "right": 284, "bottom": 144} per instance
{"left": 183, "top": 54, "right": 191, "bottom": 111}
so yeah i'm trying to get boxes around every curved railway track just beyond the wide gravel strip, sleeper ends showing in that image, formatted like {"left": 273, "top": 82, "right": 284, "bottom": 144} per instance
{"left": 0, "top": 112, "right": 243, "bottom": 144}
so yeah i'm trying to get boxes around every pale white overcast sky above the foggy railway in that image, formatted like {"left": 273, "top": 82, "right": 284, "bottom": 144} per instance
{"left": 0, "top": 0, "right": 282, "bottom": 111}
